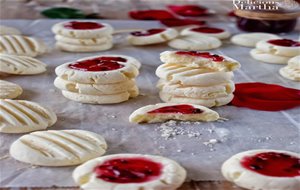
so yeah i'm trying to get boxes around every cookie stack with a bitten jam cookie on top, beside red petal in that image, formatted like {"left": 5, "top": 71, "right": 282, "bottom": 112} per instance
{"left": 156, "top": 51, "right": 240, "bottom": 107}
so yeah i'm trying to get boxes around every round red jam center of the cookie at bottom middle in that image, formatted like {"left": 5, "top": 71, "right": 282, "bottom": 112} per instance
{"left": 94, "top": 158, "right": 163, "bottom": 183}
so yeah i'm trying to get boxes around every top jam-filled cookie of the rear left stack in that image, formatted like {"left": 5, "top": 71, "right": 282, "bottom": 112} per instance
{"left": 52, "top": 21, "right": 113, "bottom": 39}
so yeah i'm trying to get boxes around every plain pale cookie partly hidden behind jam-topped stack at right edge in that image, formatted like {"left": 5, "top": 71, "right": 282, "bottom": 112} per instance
{"left": 231, "top": 32, "right": 280, "bottom": 47}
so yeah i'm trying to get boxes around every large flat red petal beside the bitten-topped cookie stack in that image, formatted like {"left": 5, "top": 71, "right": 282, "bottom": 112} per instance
{"left": 231, "top": 82, "right": 300, "bottom": 111}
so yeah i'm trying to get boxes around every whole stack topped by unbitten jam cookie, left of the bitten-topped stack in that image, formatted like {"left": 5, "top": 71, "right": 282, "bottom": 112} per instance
{"left": 54, "top": 55, "right": 141, "bottom": 104}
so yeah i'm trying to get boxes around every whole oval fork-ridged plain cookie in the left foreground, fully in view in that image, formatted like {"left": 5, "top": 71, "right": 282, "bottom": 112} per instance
{"left": 10, "top": 130, "right": 107, "bottom": 166}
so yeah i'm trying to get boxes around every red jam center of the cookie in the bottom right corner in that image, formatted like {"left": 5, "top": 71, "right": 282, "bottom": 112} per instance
{"left": 241, "top": 152, "right": 300, "bottom": 177}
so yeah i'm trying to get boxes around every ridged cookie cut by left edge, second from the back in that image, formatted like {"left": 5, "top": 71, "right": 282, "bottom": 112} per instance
{"left": 0, "top": 53, "right": 46, "bottom": 75}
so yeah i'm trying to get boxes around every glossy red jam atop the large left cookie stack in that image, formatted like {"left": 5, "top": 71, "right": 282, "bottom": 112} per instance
{"left": 69, "top": 57, "right": 126, "bottom": 71}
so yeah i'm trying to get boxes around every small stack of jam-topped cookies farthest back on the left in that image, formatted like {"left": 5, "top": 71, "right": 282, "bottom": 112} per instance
{"left": 52, "top": 21, "right": 113, "bottom": 52}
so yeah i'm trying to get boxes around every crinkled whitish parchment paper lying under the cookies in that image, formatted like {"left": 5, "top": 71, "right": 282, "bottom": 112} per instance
{"left": 0, "top": 20, "right": 300, "bottom": 187}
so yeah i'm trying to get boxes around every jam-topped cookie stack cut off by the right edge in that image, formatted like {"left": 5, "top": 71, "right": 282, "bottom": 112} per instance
{"left": 250, "top": 39, "right": 300, "bottom": 64}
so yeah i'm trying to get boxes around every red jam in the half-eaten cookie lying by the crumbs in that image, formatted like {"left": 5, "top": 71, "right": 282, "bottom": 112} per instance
{"left": 148, "top": 105, "right": 203, "bottom": 114}
